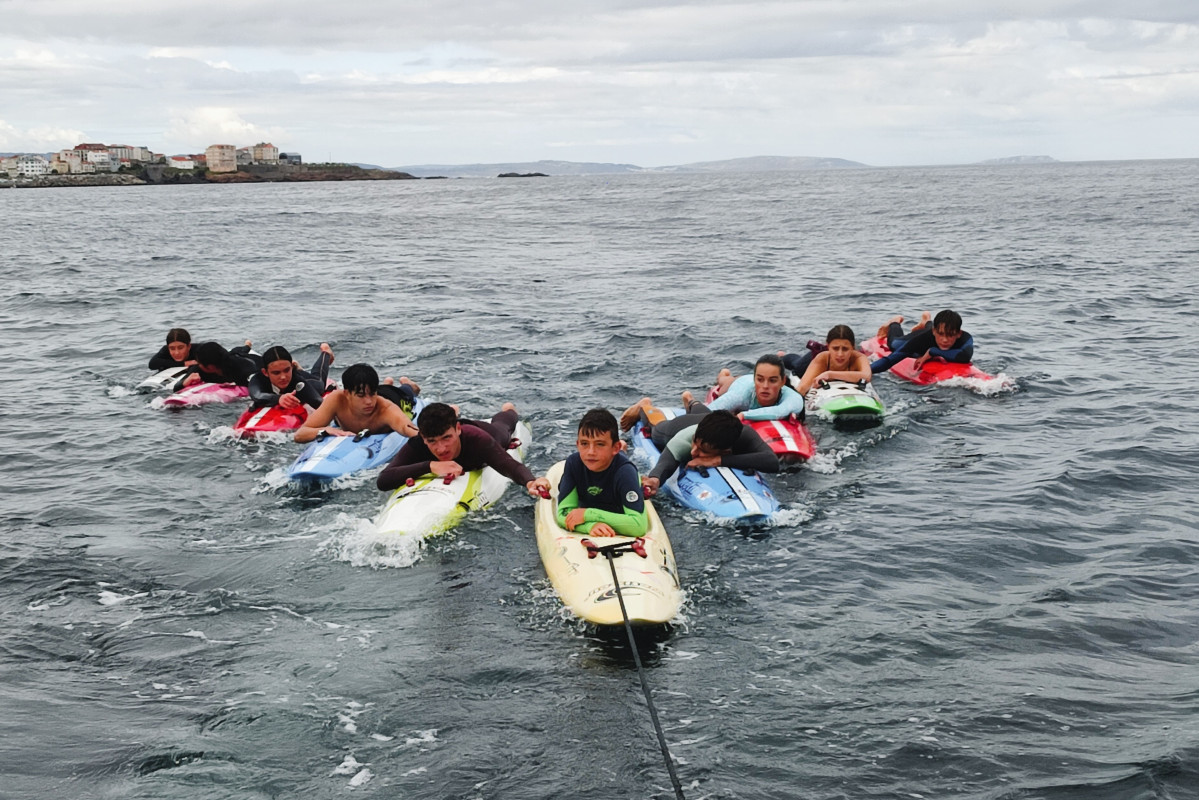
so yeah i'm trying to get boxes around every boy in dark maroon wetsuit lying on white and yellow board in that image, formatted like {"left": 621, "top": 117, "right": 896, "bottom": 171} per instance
{"left": 375, "top": 403, "right": 549, "bottom": 495}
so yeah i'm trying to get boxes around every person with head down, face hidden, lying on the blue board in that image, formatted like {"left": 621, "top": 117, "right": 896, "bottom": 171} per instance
{"left": 641, "top": 403, "right": 778, "bottom": 497}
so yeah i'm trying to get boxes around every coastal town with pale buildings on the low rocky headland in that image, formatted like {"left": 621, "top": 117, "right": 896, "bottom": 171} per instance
{"left": 0, "top": 142, "right": 412, "bottom": 186}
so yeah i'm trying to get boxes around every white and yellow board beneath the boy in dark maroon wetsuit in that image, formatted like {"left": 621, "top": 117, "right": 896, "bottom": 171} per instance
{"left": 375, "top": 421, "right": 532, "bottom": 537}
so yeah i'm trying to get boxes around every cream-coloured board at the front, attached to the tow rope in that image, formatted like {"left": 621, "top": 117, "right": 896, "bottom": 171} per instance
{"left": 534, "top": 462, "right": 682, "bottom": 625}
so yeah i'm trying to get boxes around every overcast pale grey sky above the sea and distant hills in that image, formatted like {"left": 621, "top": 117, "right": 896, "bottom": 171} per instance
{"left": 0, "top": 0, "right": 1199, "bottom": 167}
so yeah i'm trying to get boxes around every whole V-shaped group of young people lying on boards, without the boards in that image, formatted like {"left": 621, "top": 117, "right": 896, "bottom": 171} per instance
{"left": 150, "top": 311, "right": 974, "bottom": 536}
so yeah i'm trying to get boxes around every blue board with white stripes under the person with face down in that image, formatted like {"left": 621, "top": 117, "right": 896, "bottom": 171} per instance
{"left": 632, "top": 409, "right": 779, "bottom": 522}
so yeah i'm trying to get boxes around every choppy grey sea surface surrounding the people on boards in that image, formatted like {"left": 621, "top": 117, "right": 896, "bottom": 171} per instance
{"left": 0, "top": 161, "right": 1199, "bottom": 800}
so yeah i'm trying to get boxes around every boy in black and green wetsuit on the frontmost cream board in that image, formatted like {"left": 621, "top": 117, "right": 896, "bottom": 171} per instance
{"left": 558, "top": 408, "right": 649, "bottom": 536}
